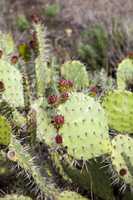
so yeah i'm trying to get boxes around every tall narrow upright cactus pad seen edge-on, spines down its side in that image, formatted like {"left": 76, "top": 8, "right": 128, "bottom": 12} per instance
{"left": 34, "top": 23, "right": 51, "bottom": 97}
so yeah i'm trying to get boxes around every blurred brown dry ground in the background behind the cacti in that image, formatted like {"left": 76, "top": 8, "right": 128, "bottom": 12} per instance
{"left": 0, "top": 0, "right": 133, "bottom": 62}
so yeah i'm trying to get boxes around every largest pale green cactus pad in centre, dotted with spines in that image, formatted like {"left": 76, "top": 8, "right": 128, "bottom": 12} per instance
{"left": 53, "top": 92, "right": 111, "bottom": 160}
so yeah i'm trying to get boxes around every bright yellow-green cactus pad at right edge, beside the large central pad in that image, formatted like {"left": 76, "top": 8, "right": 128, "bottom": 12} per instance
{"left": 102, "top": 90, "right": 133, "bottom": 133}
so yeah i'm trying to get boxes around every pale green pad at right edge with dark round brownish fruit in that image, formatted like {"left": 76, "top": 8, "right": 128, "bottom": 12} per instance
{"left": 111, "top": 135, "right": 133, "bottom": 186}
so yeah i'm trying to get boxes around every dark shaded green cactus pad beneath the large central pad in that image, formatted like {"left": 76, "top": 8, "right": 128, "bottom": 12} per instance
{"left": 51, "top": 152, "right": 115, "bottom": 200}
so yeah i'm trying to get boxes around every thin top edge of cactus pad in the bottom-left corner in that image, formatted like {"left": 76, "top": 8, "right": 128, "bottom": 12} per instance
{"left": 0, "top": 194, "right": 32, "bottom": 200}
